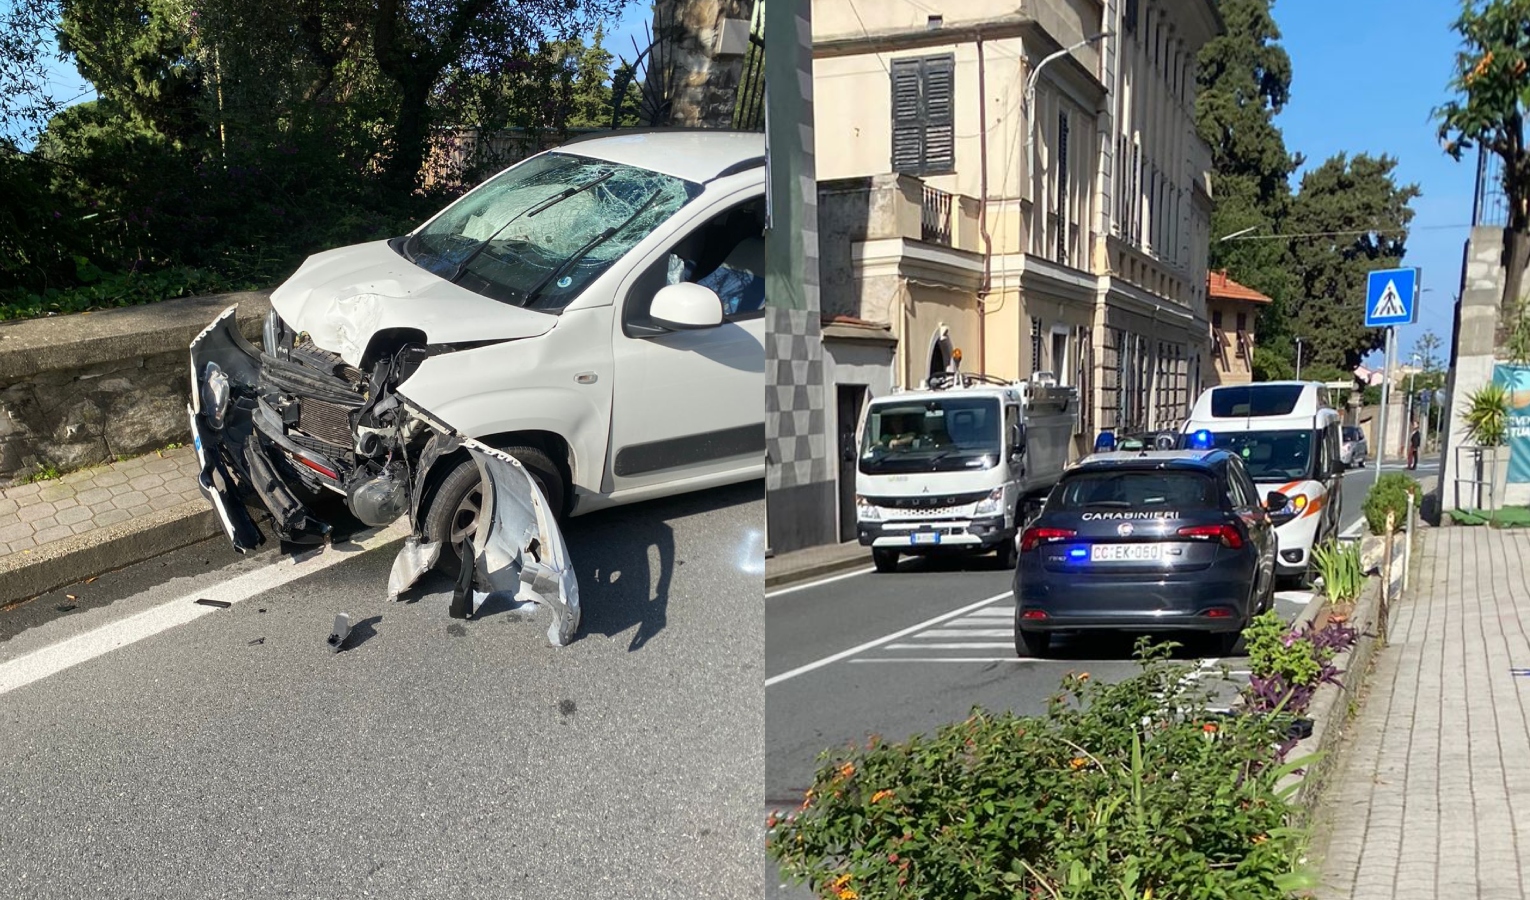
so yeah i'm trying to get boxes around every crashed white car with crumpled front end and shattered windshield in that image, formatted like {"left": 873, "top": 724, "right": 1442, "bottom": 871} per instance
{"left": 188, "top": 132, "right": 765, "bottom": 644}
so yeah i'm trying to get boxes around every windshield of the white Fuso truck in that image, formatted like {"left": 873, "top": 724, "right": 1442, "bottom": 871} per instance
{"left": 860, "top": 396, "right": 1004, "bottom": 474}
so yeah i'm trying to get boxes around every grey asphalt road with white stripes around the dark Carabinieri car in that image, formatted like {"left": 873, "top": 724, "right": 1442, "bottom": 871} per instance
{"left": 765, "top": 464, "right": 1401, "bottom": 898}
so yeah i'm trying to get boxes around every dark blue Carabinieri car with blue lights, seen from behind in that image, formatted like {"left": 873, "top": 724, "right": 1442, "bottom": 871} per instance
{"left": 1014, "top": 450, "right": 1285, "bottom": 657}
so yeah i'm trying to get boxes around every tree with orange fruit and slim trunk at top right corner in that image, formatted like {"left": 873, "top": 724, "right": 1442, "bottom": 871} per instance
{"left": 1434, "top": 0, "right": 1530, "bottom": 347}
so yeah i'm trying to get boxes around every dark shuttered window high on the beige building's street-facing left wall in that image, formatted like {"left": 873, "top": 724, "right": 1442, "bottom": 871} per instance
{"left": 892, "top": 54, "right": 956, "bottom": 174}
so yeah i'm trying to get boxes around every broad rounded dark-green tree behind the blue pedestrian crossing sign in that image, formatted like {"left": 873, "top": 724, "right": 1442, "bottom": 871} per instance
{"left": 1285, "top": 153, "right": 1418, "bottom": 370}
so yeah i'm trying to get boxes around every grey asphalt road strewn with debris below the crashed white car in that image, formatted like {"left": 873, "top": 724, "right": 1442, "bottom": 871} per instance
{"left": 0, "top": 482, "right": 765, "bottom": 900}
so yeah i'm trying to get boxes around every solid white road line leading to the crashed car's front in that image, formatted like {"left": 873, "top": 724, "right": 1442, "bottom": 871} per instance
{"left": 0, "top": 519, "right": 409, "bottom": 695}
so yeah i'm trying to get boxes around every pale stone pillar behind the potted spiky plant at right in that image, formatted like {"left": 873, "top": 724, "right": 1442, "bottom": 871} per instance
{"left": 1440, "top": 227, "right": 1504, "bottom": 510}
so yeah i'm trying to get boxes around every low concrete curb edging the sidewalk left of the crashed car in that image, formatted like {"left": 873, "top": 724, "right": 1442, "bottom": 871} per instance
{"left": 0, "top": 497, "right": 223, "bottom": 608}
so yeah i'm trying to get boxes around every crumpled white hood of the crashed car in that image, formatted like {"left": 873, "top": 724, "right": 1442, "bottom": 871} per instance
{"left": 271, "top": 240, "right": 558, "bottom": 366}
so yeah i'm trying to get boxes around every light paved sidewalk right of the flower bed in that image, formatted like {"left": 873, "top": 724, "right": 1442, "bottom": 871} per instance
{"left": 1317, "top": 527, "right": 1530, "bottom": 900}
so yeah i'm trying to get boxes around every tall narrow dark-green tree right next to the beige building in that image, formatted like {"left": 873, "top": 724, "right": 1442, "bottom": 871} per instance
{"left": 1195, "top": 0, "right": 1301, "bottom": 365}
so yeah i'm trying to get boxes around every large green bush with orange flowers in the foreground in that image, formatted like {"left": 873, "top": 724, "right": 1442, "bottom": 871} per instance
{"left": 767, "top": 660, "right": 1310, "bottom": 900}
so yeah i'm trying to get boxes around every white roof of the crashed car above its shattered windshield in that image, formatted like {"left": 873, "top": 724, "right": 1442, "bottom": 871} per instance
{"left": 554, "top": 129, "right": 765, "bottom": 182}
